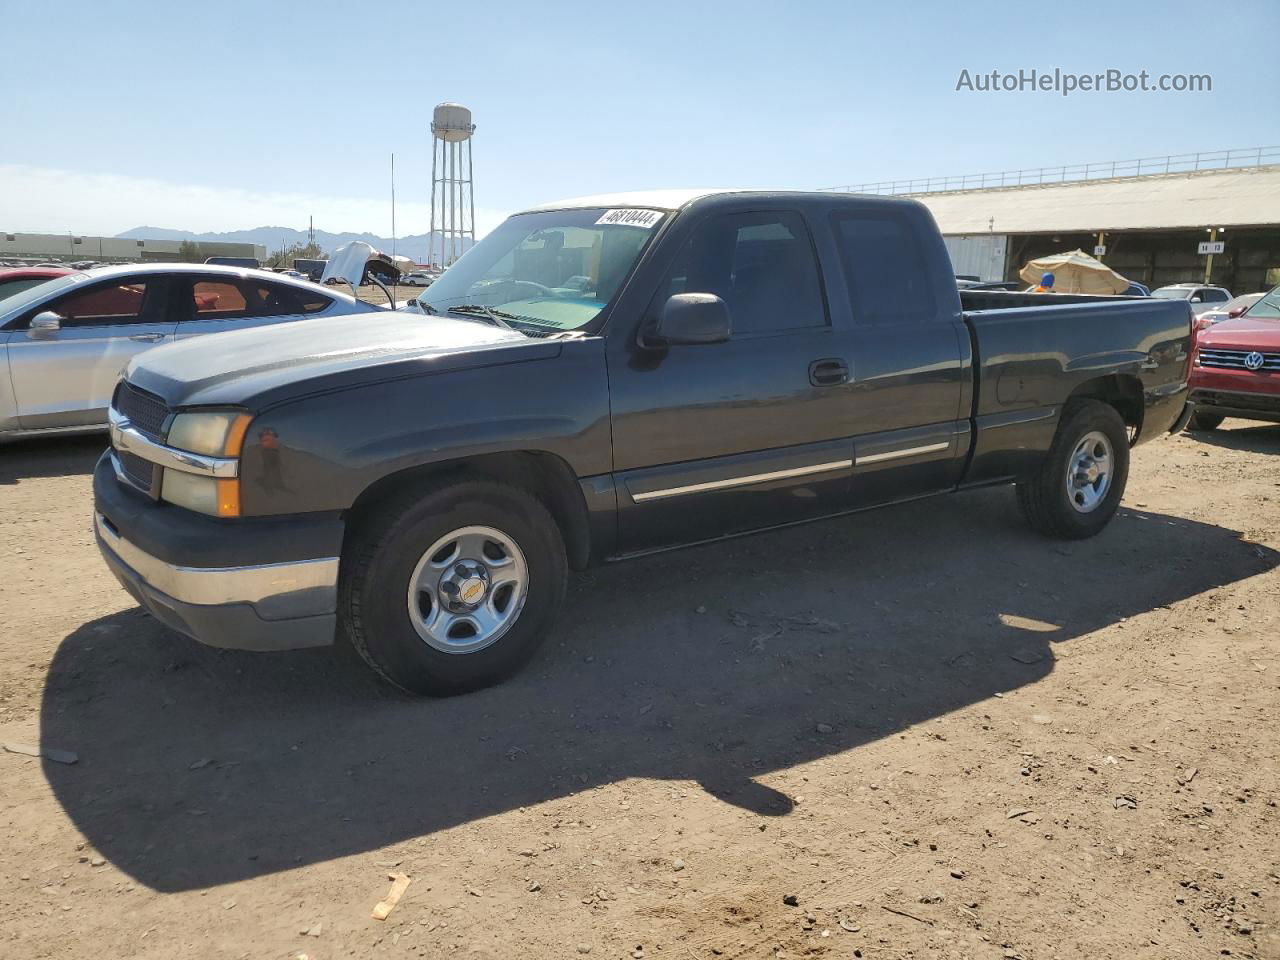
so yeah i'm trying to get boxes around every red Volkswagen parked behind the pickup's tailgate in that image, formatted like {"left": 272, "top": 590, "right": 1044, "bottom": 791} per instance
{"left": 1190, "top": 287, "right": 1280, "bottom": 430}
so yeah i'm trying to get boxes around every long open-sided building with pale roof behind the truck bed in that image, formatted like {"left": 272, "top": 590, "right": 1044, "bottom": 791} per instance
{"left": 824, "top": 147, "right": 1280, "bottom": 293}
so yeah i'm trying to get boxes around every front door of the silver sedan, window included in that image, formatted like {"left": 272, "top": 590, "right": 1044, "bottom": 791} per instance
{"left": 9, "top": 275, "right": 174, "bottom": 430}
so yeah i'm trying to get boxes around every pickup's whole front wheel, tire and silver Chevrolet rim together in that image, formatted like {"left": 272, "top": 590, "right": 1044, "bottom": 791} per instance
{"left": 339, "top": 480, "right": 568, "bottom": 695}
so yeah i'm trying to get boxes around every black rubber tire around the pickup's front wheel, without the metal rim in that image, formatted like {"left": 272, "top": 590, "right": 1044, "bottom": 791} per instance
{"left": 338, "top": 479, "right": 568, "bottom": 696}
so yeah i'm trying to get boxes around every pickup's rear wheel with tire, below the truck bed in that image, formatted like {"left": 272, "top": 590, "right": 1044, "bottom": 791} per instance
{"left": 1018, "top": 399, "right": 1129, "bottom": 540}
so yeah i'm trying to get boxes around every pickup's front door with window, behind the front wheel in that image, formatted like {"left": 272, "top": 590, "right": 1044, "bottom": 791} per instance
{"left": 609, "top": 202, "right": 854, "bottom": 553}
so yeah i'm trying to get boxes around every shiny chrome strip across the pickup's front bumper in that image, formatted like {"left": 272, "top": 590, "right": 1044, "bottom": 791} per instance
{"left": 93, "top": 513, "right": 338, "bottom": 611}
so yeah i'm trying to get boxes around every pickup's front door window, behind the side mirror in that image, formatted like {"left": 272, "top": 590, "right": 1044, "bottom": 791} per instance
{"left": 654, "top": 211, "right": 827, "bottom": 335}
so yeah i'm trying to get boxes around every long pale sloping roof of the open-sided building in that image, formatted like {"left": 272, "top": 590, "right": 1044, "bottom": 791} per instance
{"left": 914, "top": 165, "right": 1280, "bottom": 234}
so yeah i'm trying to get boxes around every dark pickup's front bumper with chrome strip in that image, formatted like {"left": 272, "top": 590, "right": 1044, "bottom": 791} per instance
{"left": 93, "top": 457, "right": 340, "bottom": 650}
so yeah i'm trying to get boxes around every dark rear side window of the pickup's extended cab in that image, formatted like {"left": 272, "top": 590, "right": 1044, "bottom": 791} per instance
{"left": 833, "top": 212, "right": 937, "bottom": 326}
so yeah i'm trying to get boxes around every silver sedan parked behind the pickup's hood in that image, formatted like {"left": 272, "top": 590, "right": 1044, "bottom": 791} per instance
{"left": 0, "top": 264, "right": 381, "bottom": 440}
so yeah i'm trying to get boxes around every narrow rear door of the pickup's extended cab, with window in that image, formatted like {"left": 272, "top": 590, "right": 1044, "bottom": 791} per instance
{"left": 831, "top": 201, "right": 972, "bottom": 506}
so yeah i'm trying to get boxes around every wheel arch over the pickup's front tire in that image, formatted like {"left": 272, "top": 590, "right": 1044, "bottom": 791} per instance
{"left": 343, "top": 451, "right": 591, "bottom": 570}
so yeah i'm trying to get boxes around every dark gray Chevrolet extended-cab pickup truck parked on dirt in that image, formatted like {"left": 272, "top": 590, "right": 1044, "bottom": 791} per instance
{"left": 95, "top": 192, "right": 1192, "bottom": 694}
